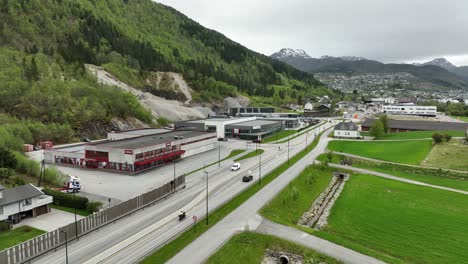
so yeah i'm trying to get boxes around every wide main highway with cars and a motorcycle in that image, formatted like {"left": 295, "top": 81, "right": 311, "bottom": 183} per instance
{"left": 33, "top": 121, "right": 332, "bottom": 264}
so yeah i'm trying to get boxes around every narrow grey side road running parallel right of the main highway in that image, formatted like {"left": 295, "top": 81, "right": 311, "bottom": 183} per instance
{"left": 168, "top": 127, "right": 358, "bottom": 264}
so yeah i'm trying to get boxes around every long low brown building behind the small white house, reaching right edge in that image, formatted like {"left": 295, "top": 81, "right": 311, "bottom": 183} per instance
{"left": 361, "top": 119, "right": 468, "bottom": 133}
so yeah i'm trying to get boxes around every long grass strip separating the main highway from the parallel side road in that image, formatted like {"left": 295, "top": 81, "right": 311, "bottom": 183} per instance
{"left": 141, "top": 132, "right": 323, "bottom": 264}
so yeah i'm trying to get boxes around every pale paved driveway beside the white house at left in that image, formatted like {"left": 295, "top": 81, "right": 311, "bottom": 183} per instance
{"left": 13, "top": 208, "right": 84, "bottom": 232}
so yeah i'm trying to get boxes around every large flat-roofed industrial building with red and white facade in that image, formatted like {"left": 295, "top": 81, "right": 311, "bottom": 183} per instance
{"left": 44, "top": 130, "right": 218, "bottom": 174}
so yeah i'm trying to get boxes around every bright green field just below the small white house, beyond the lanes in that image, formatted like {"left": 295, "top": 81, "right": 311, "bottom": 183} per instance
{"left": 328, "top": 140, "right": 432, "bottom": 164}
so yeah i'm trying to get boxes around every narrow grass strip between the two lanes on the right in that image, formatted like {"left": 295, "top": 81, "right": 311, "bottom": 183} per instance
{"left": 317, "top": 154, "right": 468, "bottom": 191}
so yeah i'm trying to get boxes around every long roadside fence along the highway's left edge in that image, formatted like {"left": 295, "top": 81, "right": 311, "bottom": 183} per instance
{"left": 0, "top": 175, "right": 185, "bottom": 264}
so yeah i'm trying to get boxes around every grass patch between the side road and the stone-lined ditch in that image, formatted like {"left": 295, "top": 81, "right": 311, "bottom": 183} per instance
{"left": 260, "top": 165, "right": 333, "bottom": 226}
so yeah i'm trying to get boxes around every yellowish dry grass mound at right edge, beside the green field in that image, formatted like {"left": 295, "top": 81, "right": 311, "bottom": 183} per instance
{"left": 423, "top": 139, "right": 468, "bottom": 171}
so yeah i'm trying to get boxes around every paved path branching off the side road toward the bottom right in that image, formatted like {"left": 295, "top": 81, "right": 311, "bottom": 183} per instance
{"left": 256, "top": 219, "right": 385, "bottom": 264}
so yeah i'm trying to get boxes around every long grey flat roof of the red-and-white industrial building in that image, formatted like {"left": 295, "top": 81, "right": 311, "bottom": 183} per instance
{"left": 89, "top": 130, "right": 211, "bottom": 149}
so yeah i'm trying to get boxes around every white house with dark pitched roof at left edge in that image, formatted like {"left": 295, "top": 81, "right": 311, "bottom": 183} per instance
{"left": 0, "top": 184, "right": 52, "bottom": 224}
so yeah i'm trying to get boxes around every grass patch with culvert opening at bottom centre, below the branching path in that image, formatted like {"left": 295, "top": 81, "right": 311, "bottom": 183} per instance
{"left": 206, "top": 232, "right": 341, "bottom": 264}
